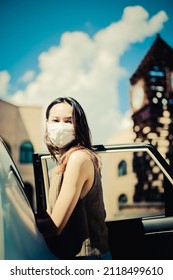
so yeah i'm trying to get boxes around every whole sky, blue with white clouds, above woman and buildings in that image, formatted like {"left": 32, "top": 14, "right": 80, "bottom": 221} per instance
{"left": 0, "top": 0, "right": 173, "bottom": 142}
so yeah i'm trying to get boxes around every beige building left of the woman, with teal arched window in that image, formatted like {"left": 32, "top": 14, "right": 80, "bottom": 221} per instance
{"left": 0, "top": 100, "right": 43, "bottom": 208}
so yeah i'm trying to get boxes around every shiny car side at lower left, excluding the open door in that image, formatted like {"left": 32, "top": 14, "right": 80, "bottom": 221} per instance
{"left": 0, "top": 140, "right": 56, "bottom": 260}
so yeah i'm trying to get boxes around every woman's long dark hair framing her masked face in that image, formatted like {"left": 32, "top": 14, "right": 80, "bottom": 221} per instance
{"left": 45, "top": 97, "right": 92, "bottom": 161}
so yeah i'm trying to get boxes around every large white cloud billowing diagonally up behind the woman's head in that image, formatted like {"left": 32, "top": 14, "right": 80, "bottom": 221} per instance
{"left": 8, "top": 6, "right": 167, "bottom": 143}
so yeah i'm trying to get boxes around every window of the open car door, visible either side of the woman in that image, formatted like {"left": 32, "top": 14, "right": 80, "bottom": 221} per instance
{"left": 33, "top": 145, "right": 172, "bottom": 221}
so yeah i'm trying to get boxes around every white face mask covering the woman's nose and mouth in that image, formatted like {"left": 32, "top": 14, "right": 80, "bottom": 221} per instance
{"left": 47, "top": 122, "right": 75, "bottom": 148}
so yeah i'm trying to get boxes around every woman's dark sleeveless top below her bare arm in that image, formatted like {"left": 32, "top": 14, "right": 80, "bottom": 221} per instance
{"left": 46, "top": 150, "right": 109, "bottom": 259}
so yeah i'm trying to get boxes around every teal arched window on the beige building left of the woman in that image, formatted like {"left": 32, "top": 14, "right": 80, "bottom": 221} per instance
{"left": 20, "top": 141, "right": 34, "bottom": 163}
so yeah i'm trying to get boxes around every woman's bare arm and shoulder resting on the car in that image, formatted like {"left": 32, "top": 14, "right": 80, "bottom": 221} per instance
{"left": 51, "top": 151, "right": 94, "bottom": 234}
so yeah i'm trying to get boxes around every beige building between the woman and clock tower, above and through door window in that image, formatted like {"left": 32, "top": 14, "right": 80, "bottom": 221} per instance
{"left": 101, "top": 128, "right": 136, "bottom": 220}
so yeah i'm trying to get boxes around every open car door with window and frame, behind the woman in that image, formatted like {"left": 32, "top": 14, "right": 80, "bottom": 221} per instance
{"left": 34, "top": 144, "right": 173, "bottom": 260}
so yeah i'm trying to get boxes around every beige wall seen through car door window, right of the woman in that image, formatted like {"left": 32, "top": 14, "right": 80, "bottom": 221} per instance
{"left": 101, "top": 149, "right": 136, "bottom": 220}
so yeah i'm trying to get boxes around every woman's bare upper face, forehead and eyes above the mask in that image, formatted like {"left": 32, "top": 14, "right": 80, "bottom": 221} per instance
{"left": 48, "top": 103, "right": 73, "bottom": 123}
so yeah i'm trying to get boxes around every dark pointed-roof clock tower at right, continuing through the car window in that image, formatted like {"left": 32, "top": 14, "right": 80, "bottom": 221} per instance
{"left": 130, "top": 35, "right": 173, "bottom": 201}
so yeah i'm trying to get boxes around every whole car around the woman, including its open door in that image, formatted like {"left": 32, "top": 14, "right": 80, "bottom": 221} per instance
{"left": 0, "top": 137, "right": 173, "bottom": 260}
